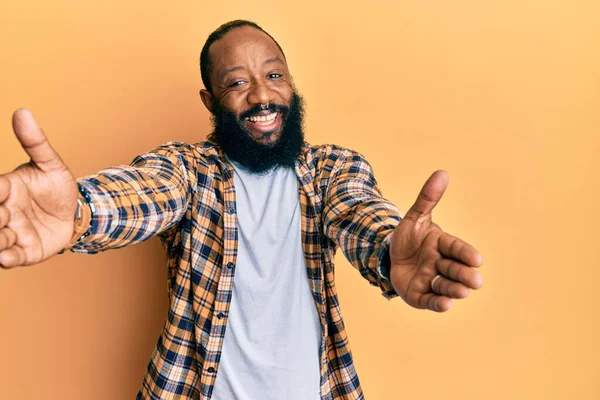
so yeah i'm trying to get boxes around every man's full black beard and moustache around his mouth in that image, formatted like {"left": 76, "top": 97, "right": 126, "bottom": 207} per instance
{"left": 209, "top": 91, "right": 304, "bottom": 174}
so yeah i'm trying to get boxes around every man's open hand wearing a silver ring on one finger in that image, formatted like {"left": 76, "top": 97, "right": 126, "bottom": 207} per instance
{"left": 390, "top": 171, "right": 483, "bottom": 312}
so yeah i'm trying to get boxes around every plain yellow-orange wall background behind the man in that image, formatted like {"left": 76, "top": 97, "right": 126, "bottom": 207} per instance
{"left": 0, "top": 0, "right": 600, "bottom": 400}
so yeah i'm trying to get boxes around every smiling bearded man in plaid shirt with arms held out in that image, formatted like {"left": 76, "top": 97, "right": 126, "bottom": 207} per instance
{"left": 0, "top": 21, "right": 482, "bottom": 400}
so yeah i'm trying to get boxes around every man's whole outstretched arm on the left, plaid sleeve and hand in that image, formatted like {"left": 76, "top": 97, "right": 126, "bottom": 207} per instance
{"left": 0, "top": 110, "right": 196, "bottom": 268}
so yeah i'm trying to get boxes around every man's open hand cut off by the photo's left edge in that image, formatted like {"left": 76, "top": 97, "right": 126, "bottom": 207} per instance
{"left": 0, "top": 109, "right": 78, "bottom": 268}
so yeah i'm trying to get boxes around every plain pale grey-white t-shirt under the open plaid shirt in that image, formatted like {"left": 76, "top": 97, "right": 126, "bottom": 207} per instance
{"left": 212, "top": 163, "right": 322, "bottom": 400}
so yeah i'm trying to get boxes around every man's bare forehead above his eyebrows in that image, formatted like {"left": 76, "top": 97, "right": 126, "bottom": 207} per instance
{"left": 208, "top": 26, "right": 285, "bottom": 76}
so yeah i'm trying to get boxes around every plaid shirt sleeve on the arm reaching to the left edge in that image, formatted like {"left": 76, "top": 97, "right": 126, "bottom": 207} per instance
{"left": 67, "top": 142, "right": 198, "bottom": 254}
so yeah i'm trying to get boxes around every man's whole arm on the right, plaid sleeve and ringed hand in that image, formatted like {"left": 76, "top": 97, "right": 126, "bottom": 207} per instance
{"left": 323, "top": 150, "right": 483, "bottom": 312}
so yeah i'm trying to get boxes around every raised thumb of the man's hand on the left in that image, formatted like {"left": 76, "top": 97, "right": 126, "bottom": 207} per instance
{"left": 13, "top": 108, "right": 64, "bottom": 172}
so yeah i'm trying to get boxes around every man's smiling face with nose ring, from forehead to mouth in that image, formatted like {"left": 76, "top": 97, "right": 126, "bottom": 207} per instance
{"left": 204, "top": 27, "right": 294, "bottom": 146}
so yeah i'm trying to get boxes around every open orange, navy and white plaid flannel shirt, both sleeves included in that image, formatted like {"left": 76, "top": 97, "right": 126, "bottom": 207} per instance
{"left": 69, "top": 141, "right": 400, "bottom": 400}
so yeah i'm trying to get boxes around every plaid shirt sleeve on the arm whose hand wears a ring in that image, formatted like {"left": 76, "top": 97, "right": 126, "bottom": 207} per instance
{"left": 323, "top": 150, "right": 400, "bottom": 299}
